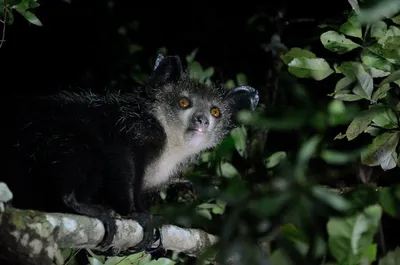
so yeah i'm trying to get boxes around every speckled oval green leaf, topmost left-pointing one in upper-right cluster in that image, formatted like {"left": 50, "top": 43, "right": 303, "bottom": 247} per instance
{"left": 320, "top": 30, "right": 361, "bottom": 54}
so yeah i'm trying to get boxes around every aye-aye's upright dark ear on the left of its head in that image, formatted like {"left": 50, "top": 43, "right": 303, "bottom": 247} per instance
{"left": 148, "top": 54, "right": 182, "bottom": 85}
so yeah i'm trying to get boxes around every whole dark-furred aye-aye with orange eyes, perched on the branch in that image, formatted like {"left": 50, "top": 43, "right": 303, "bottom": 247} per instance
{"left": 0, "top": 56, "right": 258, "bottom": 255}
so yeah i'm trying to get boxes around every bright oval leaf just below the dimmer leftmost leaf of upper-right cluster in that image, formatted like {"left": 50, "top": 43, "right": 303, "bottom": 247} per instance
{"left": 289, "top": 57, "right": 334, "bottom": 81}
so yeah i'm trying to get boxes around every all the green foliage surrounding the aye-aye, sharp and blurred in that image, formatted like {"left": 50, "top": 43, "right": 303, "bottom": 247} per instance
{"left": 0, "top": 0, "right": 400, "bottom": 265}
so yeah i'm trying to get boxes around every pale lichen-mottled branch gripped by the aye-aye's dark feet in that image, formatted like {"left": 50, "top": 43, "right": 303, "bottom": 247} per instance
{"left": 0, "top": 183, "right": 218, "bottom": 265}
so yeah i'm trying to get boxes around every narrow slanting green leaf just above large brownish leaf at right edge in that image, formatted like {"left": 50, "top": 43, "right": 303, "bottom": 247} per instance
{"left": 346, "top": 108, "right": 384, "bottom": 141}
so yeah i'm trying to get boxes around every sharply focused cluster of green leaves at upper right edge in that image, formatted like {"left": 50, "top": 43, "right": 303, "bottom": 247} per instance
{"left": 282, "top": 8, "right": 400, "bottom": 170}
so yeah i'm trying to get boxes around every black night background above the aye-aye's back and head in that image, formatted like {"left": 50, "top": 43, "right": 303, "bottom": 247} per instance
{"left": 0, "top": 0, "right": 350, "bottom": 94}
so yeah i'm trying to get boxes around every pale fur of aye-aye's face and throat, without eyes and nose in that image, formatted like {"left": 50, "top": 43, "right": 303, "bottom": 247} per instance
{"left": 143, "top": 82, "right": 230, "bottom": 189}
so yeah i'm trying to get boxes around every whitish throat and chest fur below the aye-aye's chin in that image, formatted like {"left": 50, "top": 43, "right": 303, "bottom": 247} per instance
{"left": 143, "top": 144, "right": 194, "bottom": 190}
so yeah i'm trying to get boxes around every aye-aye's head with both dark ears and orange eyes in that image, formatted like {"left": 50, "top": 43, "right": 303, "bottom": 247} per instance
{"left": 147, "top": 55, "right": 258, "bottom": 151}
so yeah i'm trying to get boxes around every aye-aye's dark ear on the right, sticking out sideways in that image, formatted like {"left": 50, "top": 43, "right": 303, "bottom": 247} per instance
{"left": 225, "top": 86, "right": 260, "bottom": 112}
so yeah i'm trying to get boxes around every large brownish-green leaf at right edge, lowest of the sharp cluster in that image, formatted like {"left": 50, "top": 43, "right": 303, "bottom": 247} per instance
{"left": 361, "top": 132, "right": 400, "bottom": 167}
